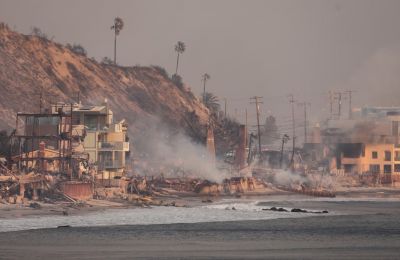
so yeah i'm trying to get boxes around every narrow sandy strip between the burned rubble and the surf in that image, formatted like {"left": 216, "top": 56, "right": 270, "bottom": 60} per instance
{"left": 0, "top": 187, "right": 400, "bottom": 221}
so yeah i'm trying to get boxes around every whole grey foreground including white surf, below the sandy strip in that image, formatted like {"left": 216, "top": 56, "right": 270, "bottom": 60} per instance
{"left": 0, "top": 190, "right": 400, "bottom": 259}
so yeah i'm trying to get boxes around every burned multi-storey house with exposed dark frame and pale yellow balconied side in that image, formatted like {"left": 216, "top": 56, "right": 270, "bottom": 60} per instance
{"left": 13, "top": 103, "right": 129, "bottom": 178}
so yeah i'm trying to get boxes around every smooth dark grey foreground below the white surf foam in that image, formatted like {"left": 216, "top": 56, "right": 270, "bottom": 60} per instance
{"left": 0, "top": 212, "right": 400, "bottom": 259}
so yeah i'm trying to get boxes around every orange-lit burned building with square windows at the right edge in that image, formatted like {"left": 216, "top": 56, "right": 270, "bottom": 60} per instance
{"left": 306, "top": 107, "right": 400, "bottom": 184}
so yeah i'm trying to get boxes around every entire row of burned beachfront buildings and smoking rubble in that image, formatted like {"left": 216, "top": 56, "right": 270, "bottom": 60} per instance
{"left": 8, "top": 101, "right": 400, "bottom": 205}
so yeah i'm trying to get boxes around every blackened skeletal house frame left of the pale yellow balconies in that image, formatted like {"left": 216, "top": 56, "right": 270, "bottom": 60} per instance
{"left": 11, "top": 105, "right": 84, "bottom": 179}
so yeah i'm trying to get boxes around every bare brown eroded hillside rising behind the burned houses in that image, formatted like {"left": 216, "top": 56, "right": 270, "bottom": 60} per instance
{"left": 0, "top": 24, "right": 208, "bottom": 144}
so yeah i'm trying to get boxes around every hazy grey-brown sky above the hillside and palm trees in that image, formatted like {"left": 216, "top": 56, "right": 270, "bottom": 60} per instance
{"left": 0, "top": 0, "right": 400, "bottom": 133}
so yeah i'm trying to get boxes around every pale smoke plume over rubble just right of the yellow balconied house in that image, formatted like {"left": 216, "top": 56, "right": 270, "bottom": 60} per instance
{"left": 134, "top": 120, "right": 229, "bottom": 183}
